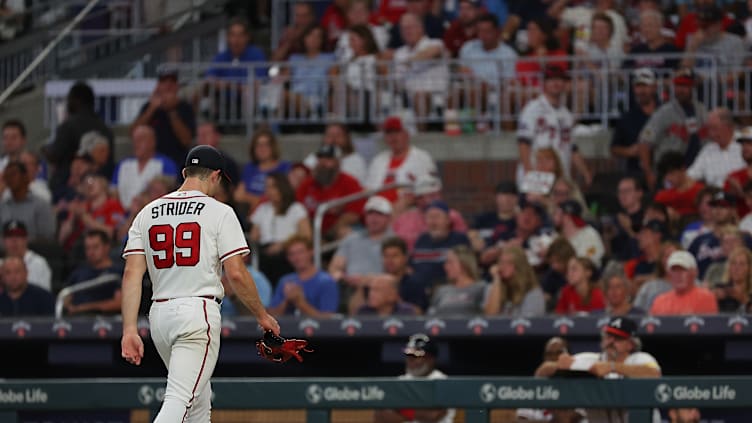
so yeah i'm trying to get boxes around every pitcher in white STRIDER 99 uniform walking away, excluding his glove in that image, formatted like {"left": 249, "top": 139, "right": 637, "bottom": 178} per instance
{"left": 121, "top": 145, "right": 279, "bottom": 423}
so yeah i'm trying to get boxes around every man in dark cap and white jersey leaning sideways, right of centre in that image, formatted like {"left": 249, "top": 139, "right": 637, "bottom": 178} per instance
{"left": 554, "top": 200, "right": 606, "bottom": 267}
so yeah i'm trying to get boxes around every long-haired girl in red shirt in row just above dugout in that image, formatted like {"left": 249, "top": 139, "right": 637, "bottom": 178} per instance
{"left": 556, "top": 257, "right": 606, "bottom": 315}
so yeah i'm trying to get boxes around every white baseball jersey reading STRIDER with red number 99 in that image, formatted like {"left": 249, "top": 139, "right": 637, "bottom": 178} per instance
{"left": 123, "top": 191, "right": 250, "bottom": 300}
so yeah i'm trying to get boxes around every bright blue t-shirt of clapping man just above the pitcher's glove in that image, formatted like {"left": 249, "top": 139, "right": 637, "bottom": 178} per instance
{"left": 269, "top": 270, "right": 339, "bottom": 314}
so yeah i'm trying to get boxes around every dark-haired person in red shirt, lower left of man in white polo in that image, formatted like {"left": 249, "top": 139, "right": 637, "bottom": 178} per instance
{"left": 654, "top": 151, "right": 705, "bottom": 216}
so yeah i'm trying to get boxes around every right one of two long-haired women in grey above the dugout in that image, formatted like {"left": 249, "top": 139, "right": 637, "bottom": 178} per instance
{"left": 483, "top": 246, "right": 546, "bottom": 317}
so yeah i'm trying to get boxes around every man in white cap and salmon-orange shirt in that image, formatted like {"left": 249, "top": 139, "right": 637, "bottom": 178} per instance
{"left": 650, "top": 251, "right": 718, "bottom": 315}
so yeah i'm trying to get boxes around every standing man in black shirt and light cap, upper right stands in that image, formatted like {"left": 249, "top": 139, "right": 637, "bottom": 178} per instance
{"left": 611, "top": 68, "right": 658, "bottom": 173}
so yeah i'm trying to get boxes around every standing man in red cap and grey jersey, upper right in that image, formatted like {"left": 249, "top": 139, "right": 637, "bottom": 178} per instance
{"left": 638, "top": 69, "right": 708, "bottom": 189}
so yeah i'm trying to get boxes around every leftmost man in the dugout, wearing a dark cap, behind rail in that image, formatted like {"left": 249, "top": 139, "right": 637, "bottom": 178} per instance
{"left": 374, "top": 333, "right": 456, "bottom": 423}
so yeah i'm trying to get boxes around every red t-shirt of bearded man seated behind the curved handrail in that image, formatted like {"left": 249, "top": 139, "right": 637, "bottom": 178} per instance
{"left": 296, "top": 172, "right": 366, "bottom": 232}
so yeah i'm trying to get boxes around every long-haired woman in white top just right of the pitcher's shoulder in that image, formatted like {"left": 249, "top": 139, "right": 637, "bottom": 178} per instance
{"left": 250, "top": 172, "right": 311, "bottom": 286}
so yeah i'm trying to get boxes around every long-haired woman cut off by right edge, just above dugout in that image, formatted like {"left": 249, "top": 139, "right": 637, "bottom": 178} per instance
{"left": 713, "top": 247, "right": 752, "bottom": 313}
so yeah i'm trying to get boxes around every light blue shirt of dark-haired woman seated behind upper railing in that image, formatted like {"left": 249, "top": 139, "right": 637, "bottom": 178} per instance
{"left": 288, "top": 53, "right": 334, "bottom": 101}
